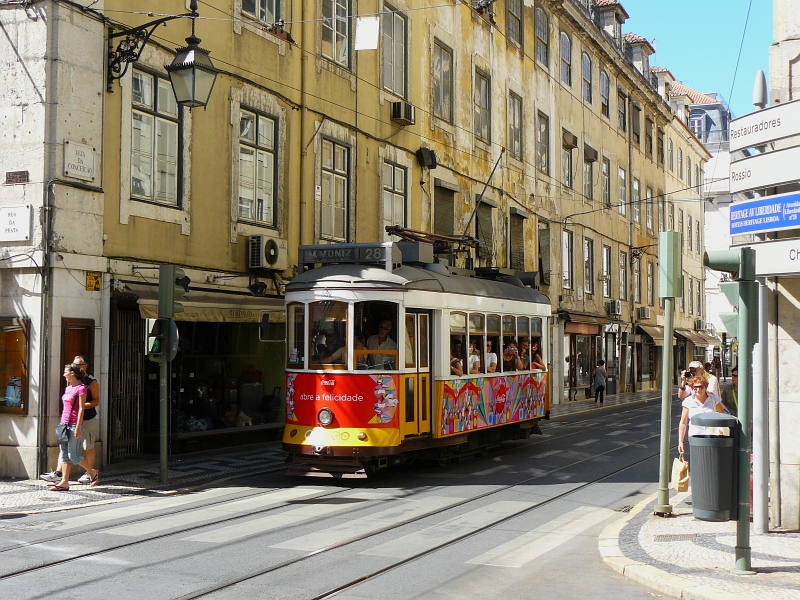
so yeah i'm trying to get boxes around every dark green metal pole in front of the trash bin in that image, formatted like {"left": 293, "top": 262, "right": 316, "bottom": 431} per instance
{"left": 733, "top": 281, "right": 758, "bottom": 575}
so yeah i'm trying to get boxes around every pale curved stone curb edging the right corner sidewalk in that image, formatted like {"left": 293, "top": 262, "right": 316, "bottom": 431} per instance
{"left": 597, "top": 493, "right": 754, "bottom": 600}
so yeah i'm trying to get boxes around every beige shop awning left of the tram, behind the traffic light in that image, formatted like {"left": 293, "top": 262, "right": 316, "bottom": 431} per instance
{"left": 115, "top": 281, "right": 286, "bottom": 323}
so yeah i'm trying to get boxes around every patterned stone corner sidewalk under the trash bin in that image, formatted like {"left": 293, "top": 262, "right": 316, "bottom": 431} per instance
{"left": 599, "top": 490, "right": 800, "bottom": 600}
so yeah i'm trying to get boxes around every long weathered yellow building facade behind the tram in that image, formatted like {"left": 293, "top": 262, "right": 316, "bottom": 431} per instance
{"left": 0, "top": 0, "right": 707, "bottom": 476}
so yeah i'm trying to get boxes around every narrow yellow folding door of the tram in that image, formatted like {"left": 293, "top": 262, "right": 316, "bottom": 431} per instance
{"left": 400, "top": 309, "right": 431, "bottom": 436}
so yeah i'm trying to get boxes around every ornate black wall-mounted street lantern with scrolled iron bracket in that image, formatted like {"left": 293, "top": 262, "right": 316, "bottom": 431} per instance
{"left": 107, "top": 0, "right": 219, "bottom": 110}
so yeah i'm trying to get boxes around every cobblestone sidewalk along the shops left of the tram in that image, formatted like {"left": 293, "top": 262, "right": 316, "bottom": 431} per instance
{"left": 0, "top": 442, "right": 286, "bottom": 517}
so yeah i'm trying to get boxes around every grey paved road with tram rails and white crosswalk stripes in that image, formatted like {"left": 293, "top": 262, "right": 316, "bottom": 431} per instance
{"left": 0, "top": 402, "right": 677, "bottom": 600}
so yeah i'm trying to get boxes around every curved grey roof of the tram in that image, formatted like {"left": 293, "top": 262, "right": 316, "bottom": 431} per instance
{"left": 286, "top": 264, "right": 550, "bottom": 306}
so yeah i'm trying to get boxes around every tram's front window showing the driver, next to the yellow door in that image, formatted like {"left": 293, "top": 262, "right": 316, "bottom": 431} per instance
{"left": 354, "top": 300, "right": 398, "bottom": 371}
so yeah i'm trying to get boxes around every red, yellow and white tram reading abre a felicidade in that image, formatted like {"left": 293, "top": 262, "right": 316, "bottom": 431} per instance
{"left": 283, "top": 242, "right": 551, "bottom": 477}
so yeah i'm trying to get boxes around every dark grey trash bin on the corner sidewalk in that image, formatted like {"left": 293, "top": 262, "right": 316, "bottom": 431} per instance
{"left": 689, "top": 413, "right": 739, "bottom": 521}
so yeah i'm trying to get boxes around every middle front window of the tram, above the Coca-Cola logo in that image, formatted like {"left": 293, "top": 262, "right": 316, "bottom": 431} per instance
{"left": 308, "top": 300, "right": 347, "bottom": 369}
